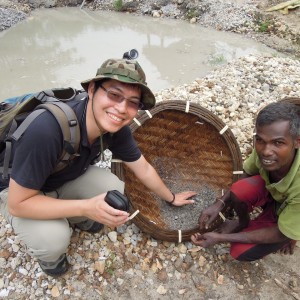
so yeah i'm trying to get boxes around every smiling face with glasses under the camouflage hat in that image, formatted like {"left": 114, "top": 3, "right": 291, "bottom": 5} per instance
{"left": 88, "top": 80, "right": 141, "bottom": 133}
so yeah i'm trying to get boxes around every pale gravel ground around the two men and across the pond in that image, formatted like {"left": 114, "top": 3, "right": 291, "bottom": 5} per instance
{"left": 0, "top": 0, "right": 300, "bottom": 300}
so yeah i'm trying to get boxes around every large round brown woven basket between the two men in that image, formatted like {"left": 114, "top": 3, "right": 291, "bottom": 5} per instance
{"left": 113, "top": 100, "right": 242, "bottom": 241}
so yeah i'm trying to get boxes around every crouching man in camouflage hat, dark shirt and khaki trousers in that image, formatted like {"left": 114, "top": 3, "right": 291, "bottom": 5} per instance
{"left": 0, "top": 59, "right": 195, "bottom": 276}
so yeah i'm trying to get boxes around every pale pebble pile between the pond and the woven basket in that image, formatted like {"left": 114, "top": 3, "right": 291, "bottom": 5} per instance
{"left": 157, "top": 55, "right": 300, "bottom": 156}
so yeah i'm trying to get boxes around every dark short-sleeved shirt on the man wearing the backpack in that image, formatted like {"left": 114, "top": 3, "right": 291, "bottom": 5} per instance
{"left": 5, "top": 99, "right": 141, "bottom": 192}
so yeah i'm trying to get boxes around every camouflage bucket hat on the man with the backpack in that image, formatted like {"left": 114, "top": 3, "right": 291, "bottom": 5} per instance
{"left": 81, "top": 59, "right": 155, "bottom": 109}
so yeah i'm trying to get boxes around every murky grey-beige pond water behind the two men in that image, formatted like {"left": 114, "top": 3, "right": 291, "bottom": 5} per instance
{"left": 0, "top": 8, "right": 278, "bottom": 99}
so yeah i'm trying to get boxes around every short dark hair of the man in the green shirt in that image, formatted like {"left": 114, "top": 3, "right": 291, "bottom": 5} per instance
{"left": 255, "top": 101, "right": 300, "bottom": 138}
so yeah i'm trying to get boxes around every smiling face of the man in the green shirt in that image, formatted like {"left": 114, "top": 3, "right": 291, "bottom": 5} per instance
{"left": 255, "top": 121, "right": 300, "bottom": 179}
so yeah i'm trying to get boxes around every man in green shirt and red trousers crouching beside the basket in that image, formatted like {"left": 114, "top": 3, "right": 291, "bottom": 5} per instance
{"left": 191, "top": 102, "right": 300, "bottom": 261}
